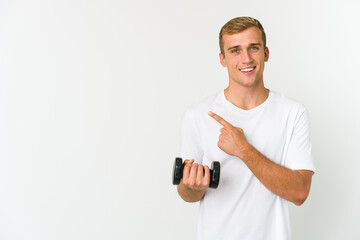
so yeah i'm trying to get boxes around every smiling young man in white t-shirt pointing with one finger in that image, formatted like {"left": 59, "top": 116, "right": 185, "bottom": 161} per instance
{"left": 178, "top": 17, "right": 315, "bottom": 240}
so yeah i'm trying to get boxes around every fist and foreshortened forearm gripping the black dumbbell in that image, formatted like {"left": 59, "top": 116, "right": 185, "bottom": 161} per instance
{"left": 178, "top": 159, "right": 210, "bottom": 202}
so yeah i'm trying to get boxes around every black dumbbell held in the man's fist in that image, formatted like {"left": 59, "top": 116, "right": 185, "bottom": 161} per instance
{"left": 173, "top": 158, "right": 220, "bottom": 188}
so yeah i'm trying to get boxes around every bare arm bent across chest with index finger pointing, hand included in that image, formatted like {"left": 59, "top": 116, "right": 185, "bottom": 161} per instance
{"left": 209, "top": 112, "right": 313, "bottom": 205}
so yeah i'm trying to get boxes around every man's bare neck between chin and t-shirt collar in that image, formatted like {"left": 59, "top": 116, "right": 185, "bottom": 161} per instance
{"left": 224, "top": 84, "right": 269, "bottom": 110}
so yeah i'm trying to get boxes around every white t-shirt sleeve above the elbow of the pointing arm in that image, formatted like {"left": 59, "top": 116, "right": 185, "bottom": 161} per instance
{"left": 285, "top": 108, "right": 315, "bottom": 172}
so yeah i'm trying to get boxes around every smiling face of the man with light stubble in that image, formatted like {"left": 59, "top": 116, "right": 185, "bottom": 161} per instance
{"left": 220, "top": 27, "right": 269, "bottom": 87}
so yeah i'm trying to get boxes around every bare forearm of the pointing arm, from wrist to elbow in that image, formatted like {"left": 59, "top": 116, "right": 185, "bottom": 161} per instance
{"left": 238, "top": 145, "right": 313, "bottom": 205}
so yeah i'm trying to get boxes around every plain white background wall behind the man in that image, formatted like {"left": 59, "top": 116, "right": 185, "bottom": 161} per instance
{"left": 0, "top": 0, "right": 360, "bottom": 240}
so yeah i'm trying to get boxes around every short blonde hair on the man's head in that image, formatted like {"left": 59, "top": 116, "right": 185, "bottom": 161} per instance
{"left": 219, "top": 17, "right": 266, "bottom": 55}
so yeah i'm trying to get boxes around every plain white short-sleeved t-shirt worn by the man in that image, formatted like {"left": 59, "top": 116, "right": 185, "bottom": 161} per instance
{"left": 181, "top": 91, "right": 315, "bottom": 240}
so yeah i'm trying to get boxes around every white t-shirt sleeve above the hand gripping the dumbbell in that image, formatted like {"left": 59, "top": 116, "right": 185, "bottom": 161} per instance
{"left": 181, "top": 110, "right": 203, "bottom": 164}
